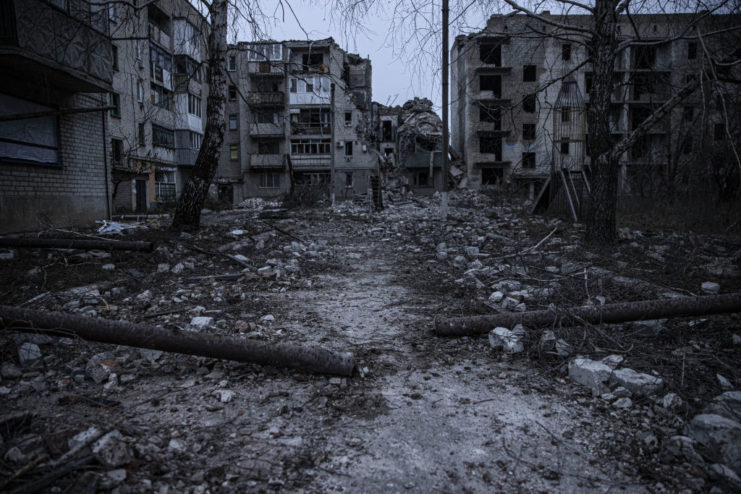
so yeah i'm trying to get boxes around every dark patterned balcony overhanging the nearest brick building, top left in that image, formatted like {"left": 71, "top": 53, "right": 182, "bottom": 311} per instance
{"left": 0, "top": 0, "right": 113, "bottom": 92}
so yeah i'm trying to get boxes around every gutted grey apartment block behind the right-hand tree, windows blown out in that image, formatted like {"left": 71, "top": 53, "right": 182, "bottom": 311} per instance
{"left": 451, "top": 12, "right": 737, "bottom": 202}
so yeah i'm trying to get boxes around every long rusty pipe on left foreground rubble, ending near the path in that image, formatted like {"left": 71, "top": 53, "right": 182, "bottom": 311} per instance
{"left": 0, "top": 305, "right": 355, "bottom": 376}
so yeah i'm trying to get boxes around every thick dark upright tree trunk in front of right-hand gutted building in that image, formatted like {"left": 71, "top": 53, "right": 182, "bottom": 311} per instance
{"left": 586, "top": 0, "right": 619, "bottom": 244}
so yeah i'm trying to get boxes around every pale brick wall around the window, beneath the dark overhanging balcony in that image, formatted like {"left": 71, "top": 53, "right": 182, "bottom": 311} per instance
{"left": 0, "top": 94, "right": 110, "bottom": 233}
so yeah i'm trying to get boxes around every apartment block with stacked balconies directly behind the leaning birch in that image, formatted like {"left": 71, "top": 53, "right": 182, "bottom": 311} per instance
{"left": 107, "top": 0, "right": 208, "bottom": 211}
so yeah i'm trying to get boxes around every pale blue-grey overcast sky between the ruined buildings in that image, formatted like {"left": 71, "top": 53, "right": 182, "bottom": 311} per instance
{"left": 229, "top": 0, "right": 506, "bottom": 112}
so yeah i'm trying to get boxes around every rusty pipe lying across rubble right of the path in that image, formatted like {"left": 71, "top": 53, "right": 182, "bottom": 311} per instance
{"left": 435, "top": 293, "right": 741, "bottom": 336}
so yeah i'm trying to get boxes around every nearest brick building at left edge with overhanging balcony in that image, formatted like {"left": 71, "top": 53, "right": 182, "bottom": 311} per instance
{"left": 0, "top": 0, "right": 112, "bottom": 232}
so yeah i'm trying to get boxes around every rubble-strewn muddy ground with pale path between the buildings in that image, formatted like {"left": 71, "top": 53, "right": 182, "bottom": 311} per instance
{"left": 0, "top": 195, "right": 741, "bottom": 494}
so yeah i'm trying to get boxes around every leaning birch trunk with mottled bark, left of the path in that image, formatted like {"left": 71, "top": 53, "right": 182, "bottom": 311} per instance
{"left": 172, "top": 0, "right": 227, "bottom": 230}
